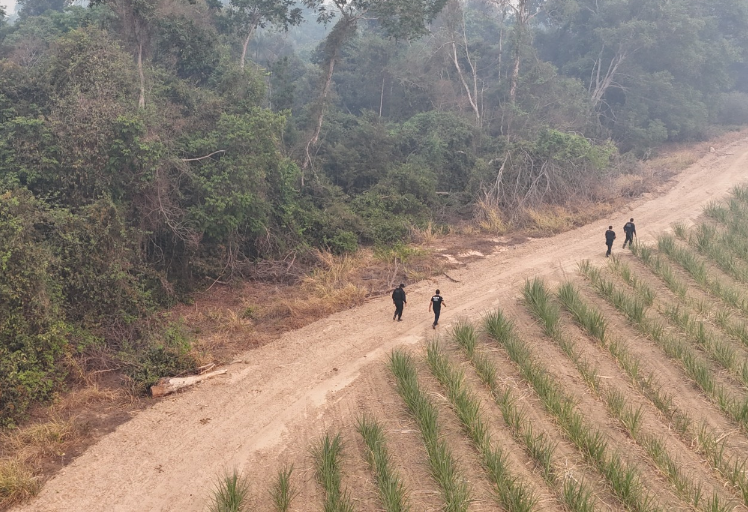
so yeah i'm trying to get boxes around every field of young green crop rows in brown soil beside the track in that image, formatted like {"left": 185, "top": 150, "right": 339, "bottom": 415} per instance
{"left": 213, "top": 187, "right": 748, "bottom": 511}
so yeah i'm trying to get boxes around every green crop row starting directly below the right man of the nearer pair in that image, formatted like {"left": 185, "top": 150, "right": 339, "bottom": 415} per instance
{"left": 426, "top": 341, "right": 538, "bottom": 512}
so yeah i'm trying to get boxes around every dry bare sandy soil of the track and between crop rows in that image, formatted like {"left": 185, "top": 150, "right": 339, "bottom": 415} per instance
{"left": 18, "top": 139, "right": 748, "bottom": 512}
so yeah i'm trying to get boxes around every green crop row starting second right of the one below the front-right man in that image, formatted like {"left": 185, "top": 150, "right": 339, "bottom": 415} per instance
{"left": 486, "top": 311, "right": 658, "bottom": 511}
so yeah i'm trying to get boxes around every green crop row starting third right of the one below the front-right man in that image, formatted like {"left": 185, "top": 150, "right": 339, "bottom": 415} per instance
{"left": 523, "top": 278, "right": 720, "bottom": 508}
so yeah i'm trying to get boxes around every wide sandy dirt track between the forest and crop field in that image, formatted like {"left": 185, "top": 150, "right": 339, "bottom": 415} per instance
{"left": 18, "top": 139, "right": 748, "bottom": 512}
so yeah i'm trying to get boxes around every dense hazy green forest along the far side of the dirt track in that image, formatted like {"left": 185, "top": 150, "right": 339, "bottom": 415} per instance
{"left": 0, "top": 0, "right": 748, "bottom": 425}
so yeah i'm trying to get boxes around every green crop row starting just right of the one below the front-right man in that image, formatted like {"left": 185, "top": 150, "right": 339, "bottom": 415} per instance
{"left": 452, "top": 322, "right": 595, "bottom": 512}
